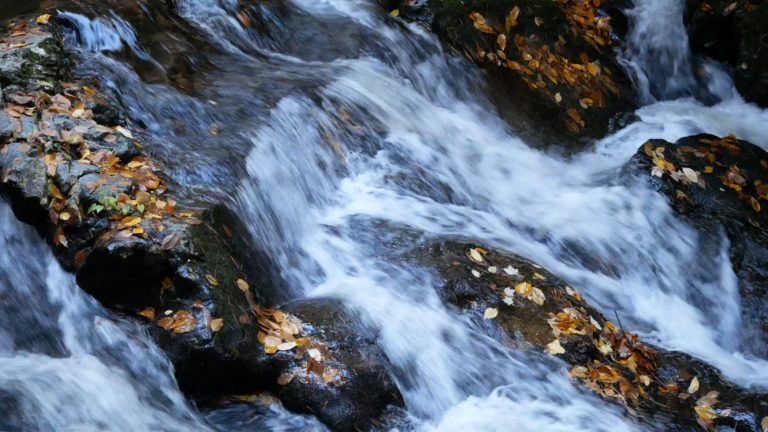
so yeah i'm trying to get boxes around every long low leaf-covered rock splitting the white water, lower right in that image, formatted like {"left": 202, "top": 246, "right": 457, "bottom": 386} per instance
{"left": 417, "top": 241, "right": 768, "bottom": 430}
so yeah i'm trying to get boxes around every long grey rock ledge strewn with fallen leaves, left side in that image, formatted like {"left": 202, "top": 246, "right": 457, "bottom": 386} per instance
{"left": 0, "top": 15, "right": 402, "bottom": 430}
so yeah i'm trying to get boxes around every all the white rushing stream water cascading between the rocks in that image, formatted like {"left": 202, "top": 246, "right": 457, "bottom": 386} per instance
{"left": 0, "top": 0, "right": 768, "bottom": 431}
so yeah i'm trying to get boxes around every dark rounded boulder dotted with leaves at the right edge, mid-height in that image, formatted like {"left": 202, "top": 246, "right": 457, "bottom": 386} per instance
{"left": 628, "top": 134, "right": 768, "bottom": 355}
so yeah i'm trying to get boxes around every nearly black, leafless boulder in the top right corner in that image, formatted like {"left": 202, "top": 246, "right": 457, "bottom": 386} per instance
{"left": 686, "top": 0, "right": 768, "bottom": 107}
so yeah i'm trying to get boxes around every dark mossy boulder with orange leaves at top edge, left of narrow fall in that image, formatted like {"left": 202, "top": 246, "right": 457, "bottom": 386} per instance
{"left": 385, "top": 0, "right": 636, "bottom": 143}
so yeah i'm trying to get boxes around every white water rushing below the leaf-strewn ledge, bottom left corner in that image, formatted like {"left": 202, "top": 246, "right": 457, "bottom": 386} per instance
{"left": 0, "top": 202, "right": 208, "bottom": 431}
